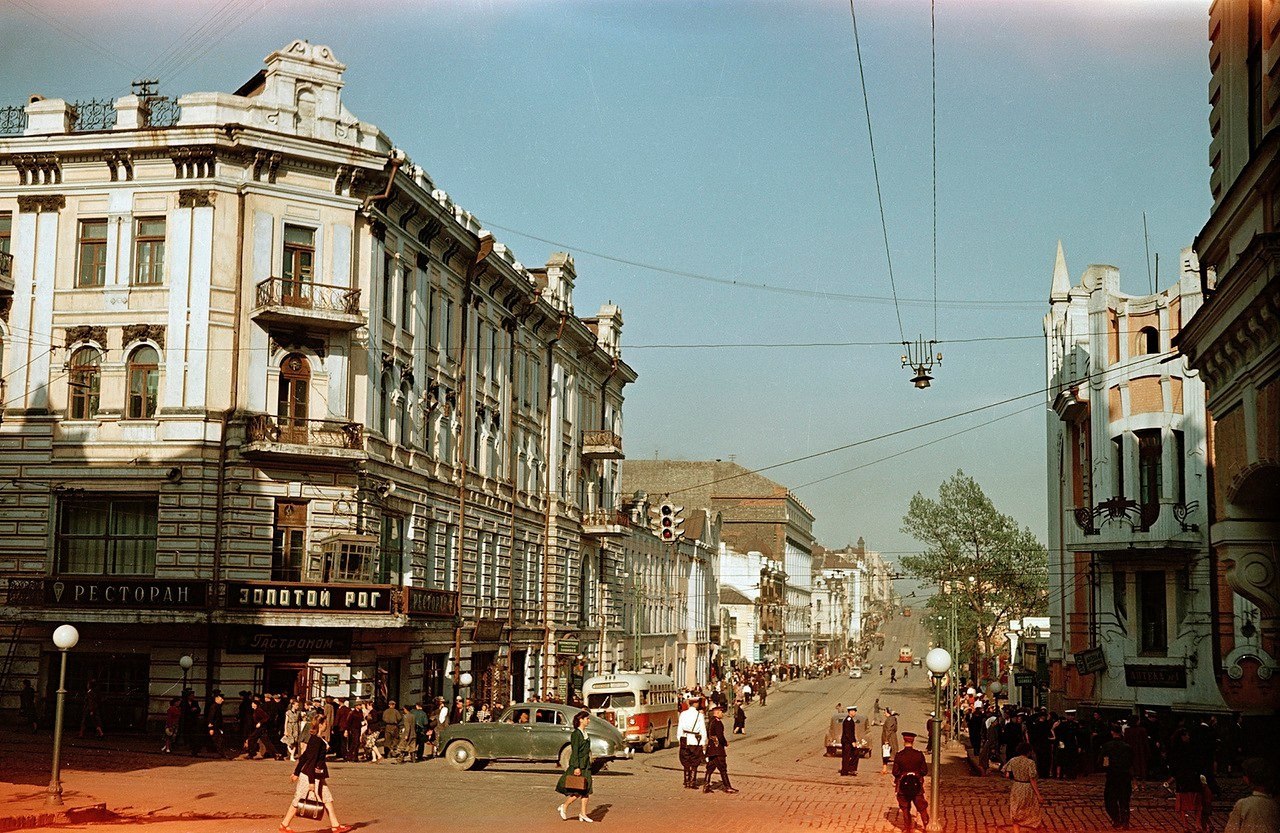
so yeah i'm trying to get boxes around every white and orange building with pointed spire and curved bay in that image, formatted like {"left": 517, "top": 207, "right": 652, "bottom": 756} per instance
{"left": 1044, "top": 244, "right": 1225, "bottom": 711}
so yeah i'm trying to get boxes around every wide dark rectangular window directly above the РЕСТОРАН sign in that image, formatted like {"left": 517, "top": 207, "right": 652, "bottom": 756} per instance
{"left": 56, "top": 496, "right": 159, "bottom": 576}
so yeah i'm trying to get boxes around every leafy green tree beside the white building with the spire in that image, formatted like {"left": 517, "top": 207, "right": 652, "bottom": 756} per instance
{"left": 902, "top": 471, "right": 1048, "bottom": 670}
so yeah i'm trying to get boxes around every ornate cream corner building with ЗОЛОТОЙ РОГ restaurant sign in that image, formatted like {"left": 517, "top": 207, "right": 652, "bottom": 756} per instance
{"left": 0, "top": 41, "right": 636, "bottom": 728}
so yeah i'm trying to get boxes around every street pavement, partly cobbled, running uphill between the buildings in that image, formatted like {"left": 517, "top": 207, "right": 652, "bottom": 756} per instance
{"left": 0, "top": 621, "right": 1239, "bottom": 833}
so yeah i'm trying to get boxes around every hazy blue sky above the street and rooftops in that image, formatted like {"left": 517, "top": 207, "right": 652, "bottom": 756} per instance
{"left": 0, "top": 0, "right": 1211, "bottom": 573}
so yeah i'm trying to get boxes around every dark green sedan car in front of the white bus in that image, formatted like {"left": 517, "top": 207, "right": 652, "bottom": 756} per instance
{"left": 439, "top": 702, "right": 631, "bottom": 772}
